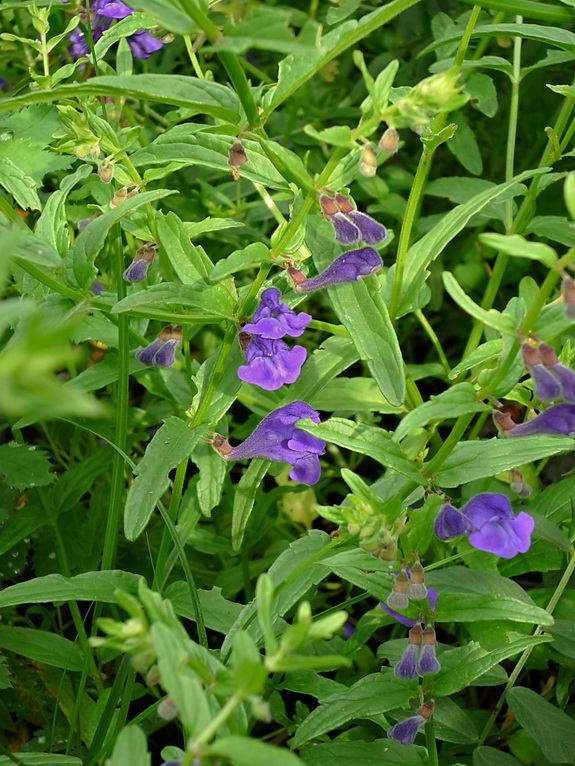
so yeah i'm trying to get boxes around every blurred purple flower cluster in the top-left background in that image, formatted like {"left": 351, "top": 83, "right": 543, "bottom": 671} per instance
{"left": 63, "top": 0, "right": 163, "bottom": 59}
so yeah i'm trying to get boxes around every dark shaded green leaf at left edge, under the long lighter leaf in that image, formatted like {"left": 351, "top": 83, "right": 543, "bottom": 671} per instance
{"left": 0, "top": 625, "right": 84, "bottom": 671}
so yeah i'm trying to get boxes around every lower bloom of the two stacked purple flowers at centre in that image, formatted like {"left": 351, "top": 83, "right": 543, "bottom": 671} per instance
{"left": 238, "top": 335, "right": 307, "bottom": 391}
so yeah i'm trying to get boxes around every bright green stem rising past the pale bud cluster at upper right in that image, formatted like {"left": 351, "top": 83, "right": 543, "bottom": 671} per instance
{"left": 389, "top": 5, "right": 481, "bottom": 321}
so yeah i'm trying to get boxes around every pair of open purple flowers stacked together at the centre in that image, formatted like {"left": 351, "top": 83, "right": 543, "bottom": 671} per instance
{"left": 238, "top": 287, "right": 311, "bottom": 391}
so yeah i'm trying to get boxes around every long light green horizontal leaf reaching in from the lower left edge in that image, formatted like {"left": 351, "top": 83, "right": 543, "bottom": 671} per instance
{"left": 0, "top": 569, "right": 140, "bottom": 609}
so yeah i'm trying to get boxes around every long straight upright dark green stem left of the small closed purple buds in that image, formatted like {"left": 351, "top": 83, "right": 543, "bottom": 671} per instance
{"left": 101, "top": 236, "right": 129, "bottom": 569}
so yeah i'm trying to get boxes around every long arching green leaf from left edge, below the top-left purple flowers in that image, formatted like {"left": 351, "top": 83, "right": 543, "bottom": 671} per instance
{"left": 0, "top": 74, "right": 240, "bottom": 125}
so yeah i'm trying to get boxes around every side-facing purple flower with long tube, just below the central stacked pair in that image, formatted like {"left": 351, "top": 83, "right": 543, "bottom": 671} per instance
{"left": 213, "top": 402, "right": 325, "bottom": 484}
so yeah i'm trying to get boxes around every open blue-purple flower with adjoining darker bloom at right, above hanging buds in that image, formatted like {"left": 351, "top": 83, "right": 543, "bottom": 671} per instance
{"left": 434, "top": 496, "right": 536, "bottom": 559}
